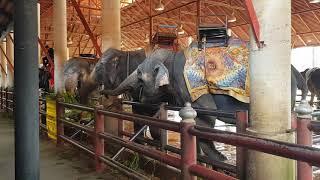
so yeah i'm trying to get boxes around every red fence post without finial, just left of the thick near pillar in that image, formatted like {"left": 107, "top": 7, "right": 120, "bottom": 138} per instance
{"left": 236, "top": 111, "right": 249, "bottom": 180}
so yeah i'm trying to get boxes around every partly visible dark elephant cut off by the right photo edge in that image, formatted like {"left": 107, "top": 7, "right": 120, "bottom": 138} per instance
{"left": 301, "top": 67, "right": 320, "bottom": 107}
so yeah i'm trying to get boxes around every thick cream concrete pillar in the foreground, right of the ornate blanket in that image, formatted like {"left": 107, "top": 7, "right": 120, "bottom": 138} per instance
{"left": 247, "top": 0, "right": 295, "bottom": 180}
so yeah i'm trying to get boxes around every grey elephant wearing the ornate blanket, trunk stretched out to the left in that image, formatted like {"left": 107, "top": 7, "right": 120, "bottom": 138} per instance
{"left": 101, "top": 49, "right": 307, "bottom": 161}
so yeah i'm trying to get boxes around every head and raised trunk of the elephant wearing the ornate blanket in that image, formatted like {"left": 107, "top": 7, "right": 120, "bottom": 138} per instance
{"left": 102, "top": 49, "right": 170, "bottom": 102}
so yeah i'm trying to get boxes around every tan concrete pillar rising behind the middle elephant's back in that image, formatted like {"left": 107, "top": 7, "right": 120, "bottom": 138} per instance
{"left": 101, "top": 0, "right": 121, "bottom": 135}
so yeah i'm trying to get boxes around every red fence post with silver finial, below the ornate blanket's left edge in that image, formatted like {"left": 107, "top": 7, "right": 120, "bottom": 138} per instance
{"left": 179, "top": 103, "right": 197, "bottom": 180}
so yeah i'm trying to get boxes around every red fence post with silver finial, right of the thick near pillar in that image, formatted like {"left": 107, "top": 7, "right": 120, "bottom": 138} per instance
{"left": 295, "top": 100, "right": 313, "bottom": 180}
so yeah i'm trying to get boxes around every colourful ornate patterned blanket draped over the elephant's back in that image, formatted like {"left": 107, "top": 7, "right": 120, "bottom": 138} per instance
{"left": 184, "top": 38, "right": 250, "bottom": 103}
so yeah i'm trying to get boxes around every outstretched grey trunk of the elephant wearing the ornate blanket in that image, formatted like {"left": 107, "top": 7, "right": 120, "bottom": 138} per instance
{"left": 101, "top": 70, "right": 138, "bottom": 96}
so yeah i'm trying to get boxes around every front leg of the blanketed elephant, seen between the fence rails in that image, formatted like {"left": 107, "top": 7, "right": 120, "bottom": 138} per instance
{"left": 192, "top": 94, "right": 227, "bottom": 161}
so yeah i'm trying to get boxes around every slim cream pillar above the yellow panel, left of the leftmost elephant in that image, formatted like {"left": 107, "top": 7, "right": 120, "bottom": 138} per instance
{"left": 53, "top": 0, "right": 68, "bottom": 93}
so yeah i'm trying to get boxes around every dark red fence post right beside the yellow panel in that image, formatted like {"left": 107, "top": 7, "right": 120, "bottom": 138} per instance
{"left": 56, "top": 97, "right": 64, "bottom": 146}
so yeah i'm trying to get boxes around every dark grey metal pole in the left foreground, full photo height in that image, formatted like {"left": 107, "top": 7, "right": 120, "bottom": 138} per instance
{"left": 14, "top": 0, "right": 40, "bottom": 180}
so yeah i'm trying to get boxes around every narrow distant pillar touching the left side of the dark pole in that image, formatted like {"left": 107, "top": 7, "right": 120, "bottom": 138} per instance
{"left": 6, "top": 33, "right": 14, "bottom": 87}
